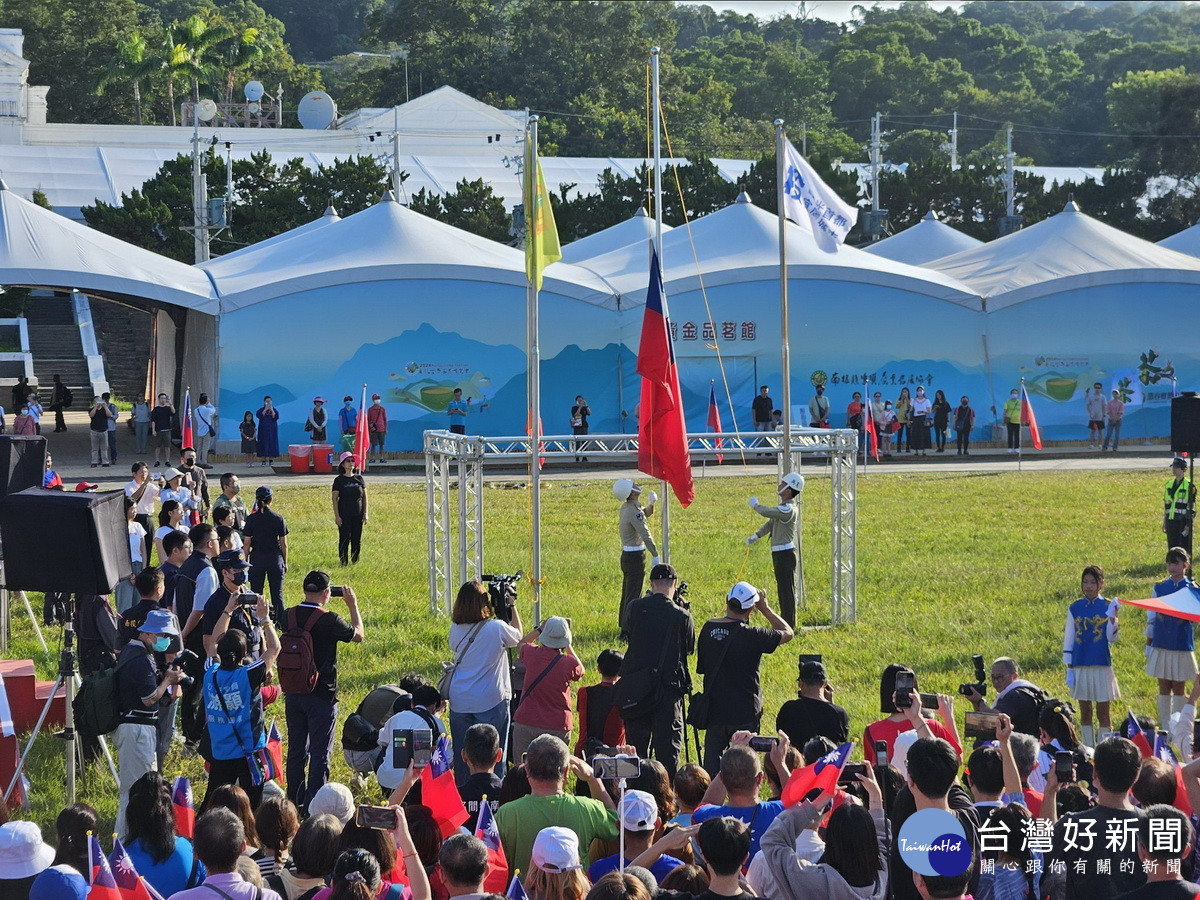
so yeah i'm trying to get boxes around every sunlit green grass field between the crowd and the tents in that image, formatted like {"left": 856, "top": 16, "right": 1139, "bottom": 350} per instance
{"left": 0, "top": 472, "right": 1180, "bottom": 834}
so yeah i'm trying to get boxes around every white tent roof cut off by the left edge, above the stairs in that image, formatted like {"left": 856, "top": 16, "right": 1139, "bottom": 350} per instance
{"left": 0, "top": 181, "right": 217, "bottom": 314}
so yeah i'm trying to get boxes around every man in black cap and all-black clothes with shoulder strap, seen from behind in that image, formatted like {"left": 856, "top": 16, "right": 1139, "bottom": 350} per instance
{"left": 616, "top": 563, "right": 696, "bottom": 778}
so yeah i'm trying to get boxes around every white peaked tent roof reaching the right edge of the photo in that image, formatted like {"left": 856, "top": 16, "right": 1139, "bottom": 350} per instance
{"left": 929, "top": 200, "right": 1200, "bottom": 311}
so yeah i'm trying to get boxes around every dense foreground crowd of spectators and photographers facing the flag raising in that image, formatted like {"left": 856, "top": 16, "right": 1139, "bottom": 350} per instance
{"left": 7, "top": 525, "right": 1200, "bottom": 900}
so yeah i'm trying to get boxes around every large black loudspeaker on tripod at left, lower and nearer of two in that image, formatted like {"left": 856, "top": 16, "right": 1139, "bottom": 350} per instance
{"left": 0, "top": 486, "right": 133, "bottom": 594}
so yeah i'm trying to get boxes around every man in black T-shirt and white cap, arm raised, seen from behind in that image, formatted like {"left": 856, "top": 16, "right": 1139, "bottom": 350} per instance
{"left": 689, "top": 581, "right": 793, "bottom": 772}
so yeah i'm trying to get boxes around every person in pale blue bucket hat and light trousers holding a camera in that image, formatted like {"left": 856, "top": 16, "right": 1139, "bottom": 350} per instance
{"left": 114, "top": 610, "right": 184, "bottom": 834}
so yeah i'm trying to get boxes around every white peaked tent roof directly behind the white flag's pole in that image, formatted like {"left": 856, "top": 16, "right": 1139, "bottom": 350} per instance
{"left": 582, "top": 192, "right": 980, "bottom": 310}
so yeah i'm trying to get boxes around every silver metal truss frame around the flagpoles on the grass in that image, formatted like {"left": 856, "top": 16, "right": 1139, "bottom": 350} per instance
{"left": 425, "top": 427, "right": 858, "bottom": 625}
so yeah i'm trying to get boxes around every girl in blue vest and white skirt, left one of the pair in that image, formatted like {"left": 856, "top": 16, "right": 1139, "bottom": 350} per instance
{"left": 1062, "top": 565, "right": 1118, "bottom": 746}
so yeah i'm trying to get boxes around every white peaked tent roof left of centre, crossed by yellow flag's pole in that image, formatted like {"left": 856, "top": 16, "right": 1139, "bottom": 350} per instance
{"left": 199, "top": 192, "right": 616, "bottom": 312}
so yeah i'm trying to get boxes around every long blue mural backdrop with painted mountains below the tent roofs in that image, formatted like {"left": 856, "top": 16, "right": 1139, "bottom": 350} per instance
{"left": 220, "top": 271, "right": 1200, "bottom": 451}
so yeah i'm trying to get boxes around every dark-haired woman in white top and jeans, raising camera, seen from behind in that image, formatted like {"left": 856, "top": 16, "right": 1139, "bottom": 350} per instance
{"left": 438, "top": 581, "right": 522, "bottom": 785}
